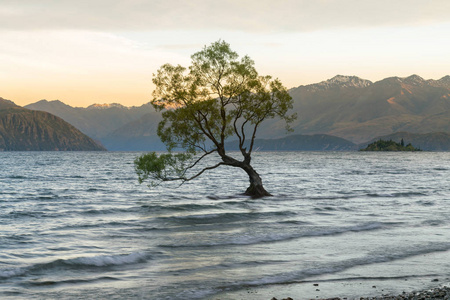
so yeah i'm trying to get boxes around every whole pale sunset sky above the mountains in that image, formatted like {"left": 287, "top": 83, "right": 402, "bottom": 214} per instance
{"left": 0, "top": 0, "right": 450, "bottom": 107}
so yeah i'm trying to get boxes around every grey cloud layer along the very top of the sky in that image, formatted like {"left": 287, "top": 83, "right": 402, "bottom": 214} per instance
{"left": 0, "top": 0, "right": 450, "bottom": 31}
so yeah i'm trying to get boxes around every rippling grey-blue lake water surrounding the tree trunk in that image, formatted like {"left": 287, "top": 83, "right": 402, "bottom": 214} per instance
{"left": 0, "top": 152, "right": 450, "bottom": 300}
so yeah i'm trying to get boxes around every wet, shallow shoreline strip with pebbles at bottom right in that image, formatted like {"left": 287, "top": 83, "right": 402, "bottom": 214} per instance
{"left": 210, "top": 277, "right": 450, "bottom": 300}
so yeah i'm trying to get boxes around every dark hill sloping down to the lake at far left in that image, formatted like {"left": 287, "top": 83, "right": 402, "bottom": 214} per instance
{"left": 0, "top": 98, "right": 105, "bottom": 151}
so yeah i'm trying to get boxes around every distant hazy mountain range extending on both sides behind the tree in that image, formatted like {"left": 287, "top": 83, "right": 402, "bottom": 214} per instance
{"left": 15, "top": 75, "right": 450, "bottom": 151}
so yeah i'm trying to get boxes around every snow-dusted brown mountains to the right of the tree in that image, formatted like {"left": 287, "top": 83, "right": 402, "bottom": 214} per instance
{"left": 282, "top": 75, "right": 450, "bottom": 143}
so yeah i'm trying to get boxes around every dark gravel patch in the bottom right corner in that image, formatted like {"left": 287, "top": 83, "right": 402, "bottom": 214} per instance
{"left": 271, "top": 286, "right": 450, "bottom": 300}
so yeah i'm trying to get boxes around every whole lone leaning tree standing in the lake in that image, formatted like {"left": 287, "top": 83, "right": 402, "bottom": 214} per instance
{"left": 135, "top": 41, "right": 296, "bottom": 197}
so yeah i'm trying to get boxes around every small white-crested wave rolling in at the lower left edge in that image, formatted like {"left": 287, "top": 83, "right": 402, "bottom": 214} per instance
{"left": 0, "top": 252, "right": 153, "bottom": 280}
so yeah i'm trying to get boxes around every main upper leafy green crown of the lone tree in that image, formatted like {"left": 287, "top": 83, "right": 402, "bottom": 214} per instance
{"left": 152, "top": 41, "right": 295, "bottom": 153}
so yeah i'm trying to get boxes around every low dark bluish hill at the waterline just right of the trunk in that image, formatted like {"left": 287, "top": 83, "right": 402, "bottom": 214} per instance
{"left": 226, "top": 134, "right": 357, "bottom": 151}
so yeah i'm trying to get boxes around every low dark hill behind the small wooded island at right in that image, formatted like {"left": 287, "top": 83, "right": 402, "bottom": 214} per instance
{"left": 358, "top": 132, "right": 450, "bottom": 151}
